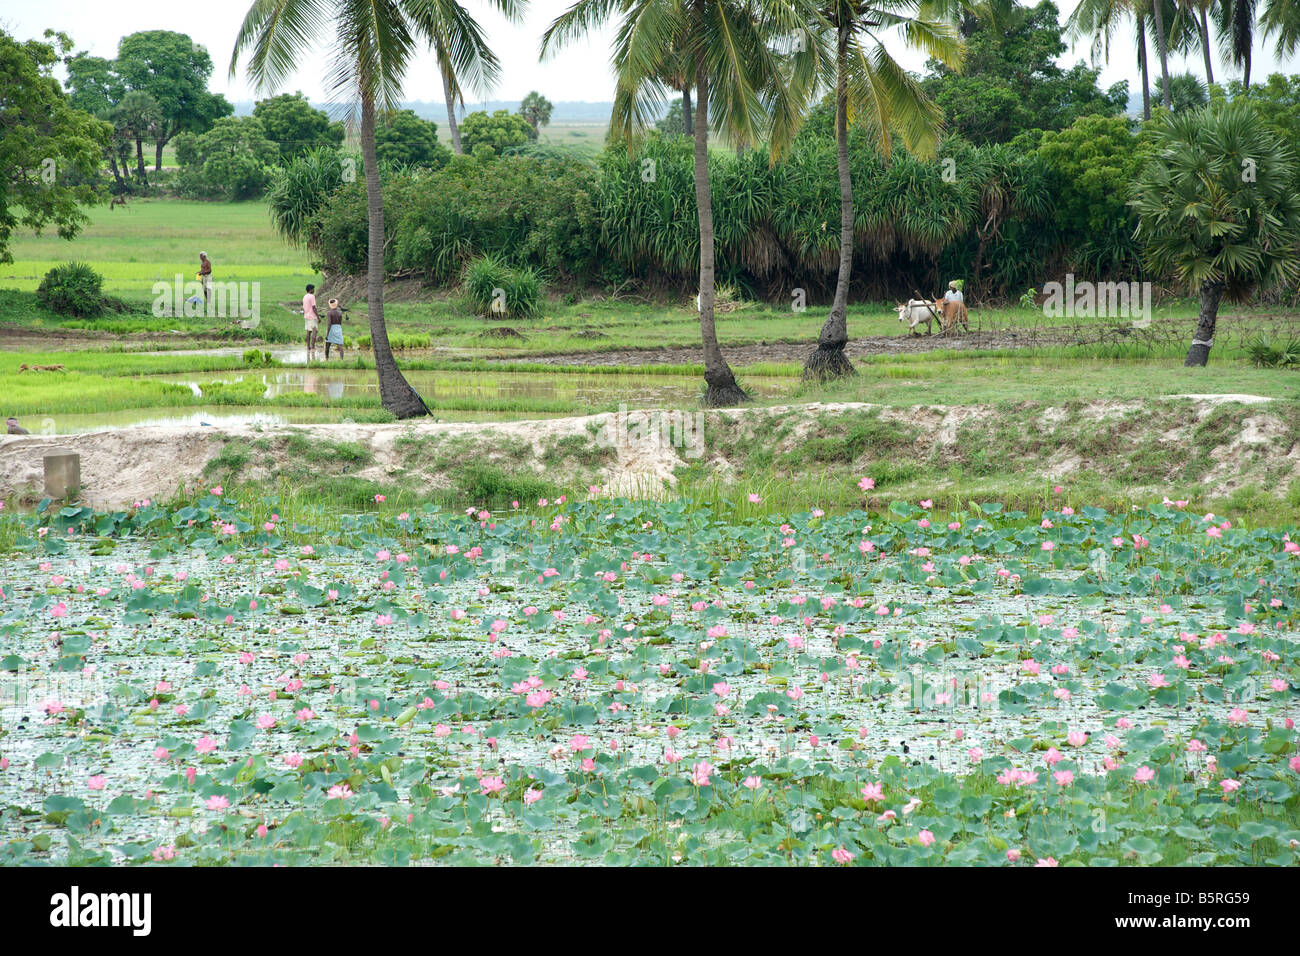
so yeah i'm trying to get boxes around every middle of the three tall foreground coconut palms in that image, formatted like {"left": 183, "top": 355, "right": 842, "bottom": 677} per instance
{"left": 541, "top": 0, "right": 819, "bottom": 407}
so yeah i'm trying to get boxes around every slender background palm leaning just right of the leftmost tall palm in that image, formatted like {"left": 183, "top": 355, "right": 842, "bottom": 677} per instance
{"left": 426, "top": 0, "right": 528, "bottom": 155}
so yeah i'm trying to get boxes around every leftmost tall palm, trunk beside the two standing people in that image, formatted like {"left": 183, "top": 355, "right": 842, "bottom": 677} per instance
{"left": 230, "top": 0, "right": 432, "bottom": 419}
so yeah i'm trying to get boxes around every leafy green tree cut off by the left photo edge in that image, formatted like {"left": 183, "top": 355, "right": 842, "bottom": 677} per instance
{"left": 0, "top": 31, "right": 112, "bottom": 263}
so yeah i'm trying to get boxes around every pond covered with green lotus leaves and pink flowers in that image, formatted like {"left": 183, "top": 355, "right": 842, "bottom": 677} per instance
{"left": 0, "top": 489, "right": 1300, "bottom": 866}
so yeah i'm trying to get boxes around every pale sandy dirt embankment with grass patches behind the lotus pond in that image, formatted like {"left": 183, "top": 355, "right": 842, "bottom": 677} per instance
{"left": 0, "top": 395, "right": 1300, "bottom": 507}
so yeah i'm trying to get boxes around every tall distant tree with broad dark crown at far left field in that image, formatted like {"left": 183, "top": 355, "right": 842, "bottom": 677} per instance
{"left": 116, "top": 30, "right": 234, "bottom": 169}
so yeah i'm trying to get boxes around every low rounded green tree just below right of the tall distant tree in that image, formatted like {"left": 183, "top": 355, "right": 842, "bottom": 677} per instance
{"left": 179, "top": 116, "right": 280, "bottom": 199}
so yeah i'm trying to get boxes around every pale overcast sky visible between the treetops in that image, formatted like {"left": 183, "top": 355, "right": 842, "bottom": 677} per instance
{"left": 0, "top": 0, "right": 1300, "bottom": 103}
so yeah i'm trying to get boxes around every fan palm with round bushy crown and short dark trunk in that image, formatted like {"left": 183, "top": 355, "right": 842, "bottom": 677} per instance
{"left": 1130, "top": 99, "right": 1300, "bottom": 365}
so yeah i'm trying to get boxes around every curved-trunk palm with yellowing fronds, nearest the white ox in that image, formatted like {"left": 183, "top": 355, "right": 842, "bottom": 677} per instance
{"left": 803, "top": 0, "right": 965, "bottom": 380}
